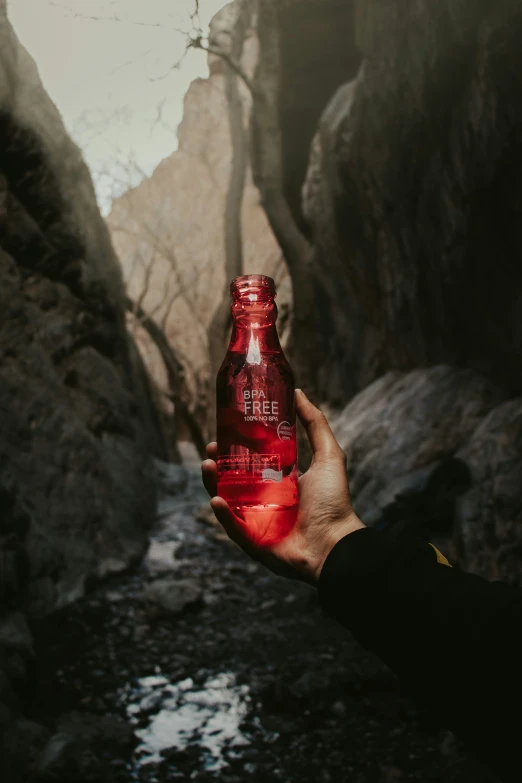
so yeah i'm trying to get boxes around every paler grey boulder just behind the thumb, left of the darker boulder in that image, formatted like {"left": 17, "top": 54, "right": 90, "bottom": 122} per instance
{"left": 332, "top": 365, "right": 504, "bottom": 529}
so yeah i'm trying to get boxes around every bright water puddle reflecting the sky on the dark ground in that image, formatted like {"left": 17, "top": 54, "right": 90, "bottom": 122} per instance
{"left": 122, "top": 673, "right": 251, "bottom": 772}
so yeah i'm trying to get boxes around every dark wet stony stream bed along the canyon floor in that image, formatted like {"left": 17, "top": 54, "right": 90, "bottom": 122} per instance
{"left": 25, "top": 455, "right": 492, "bottom": 783}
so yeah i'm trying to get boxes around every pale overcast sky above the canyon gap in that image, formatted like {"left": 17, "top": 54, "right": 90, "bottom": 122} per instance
{"left": 8, "top": 0, "right": 226, "bottom": 214}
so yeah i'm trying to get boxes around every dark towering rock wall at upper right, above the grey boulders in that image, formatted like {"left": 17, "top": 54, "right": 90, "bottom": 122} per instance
{"left": 304, "top": 0, "right": 522, "bottom": 393}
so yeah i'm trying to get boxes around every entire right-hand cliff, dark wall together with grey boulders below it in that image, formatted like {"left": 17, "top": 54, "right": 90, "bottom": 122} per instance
{"left": 290, "top": 0, "right": 522, "bottom": 582}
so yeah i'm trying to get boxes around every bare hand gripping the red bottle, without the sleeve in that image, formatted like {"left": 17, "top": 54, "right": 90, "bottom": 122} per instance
{"left": 201, "top": 389, "right": 364, "bottom": 584}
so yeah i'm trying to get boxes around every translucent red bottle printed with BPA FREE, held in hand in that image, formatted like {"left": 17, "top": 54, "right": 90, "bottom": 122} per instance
{"left": 216, "top": 275, "right": 298, "bottom": 546}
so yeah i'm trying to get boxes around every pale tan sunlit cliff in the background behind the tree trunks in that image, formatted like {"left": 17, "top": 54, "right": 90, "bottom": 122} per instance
{"left": 108, "top": 3, "right": 291, "bottom": 426}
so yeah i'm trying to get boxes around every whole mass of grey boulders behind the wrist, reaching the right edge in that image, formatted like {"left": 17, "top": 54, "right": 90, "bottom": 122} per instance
{"left": 332, "top": 365, "right": 522, "bottom": 584}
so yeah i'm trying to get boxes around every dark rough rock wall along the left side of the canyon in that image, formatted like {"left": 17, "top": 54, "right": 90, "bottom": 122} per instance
{"left": 0, "top": 0, "right": 164, "bottom": 764}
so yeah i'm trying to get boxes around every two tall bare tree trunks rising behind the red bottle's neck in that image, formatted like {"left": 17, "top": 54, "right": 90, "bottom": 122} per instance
{"left": 199, "top": 0, "right": 323, "bottom": 404}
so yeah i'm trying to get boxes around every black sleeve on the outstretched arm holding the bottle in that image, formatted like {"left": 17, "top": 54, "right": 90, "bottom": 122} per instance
{"left": 319, "top": 529, "right": 522, "bottom": 781}
